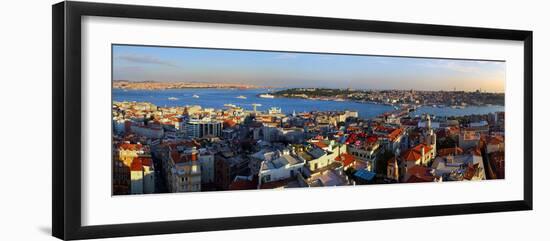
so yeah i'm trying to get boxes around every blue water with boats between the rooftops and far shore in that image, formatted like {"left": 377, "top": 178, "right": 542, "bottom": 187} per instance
{"left": 112, "top": 89, "right": 504, "bottom": 118}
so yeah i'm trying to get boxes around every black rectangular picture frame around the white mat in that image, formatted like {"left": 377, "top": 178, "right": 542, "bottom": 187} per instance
{"left": 52, "top": 1, "right": 533, "bottom": 239}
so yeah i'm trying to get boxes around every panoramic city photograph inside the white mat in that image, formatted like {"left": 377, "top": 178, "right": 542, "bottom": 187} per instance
{"left": 111, "top": 44, "right": 506, "bottom": 195}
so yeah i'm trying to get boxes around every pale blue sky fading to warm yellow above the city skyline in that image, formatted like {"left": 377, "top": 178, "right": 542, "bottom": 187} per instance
{"left": 112, "top": 45, "right": 506, "bottom": 92}
